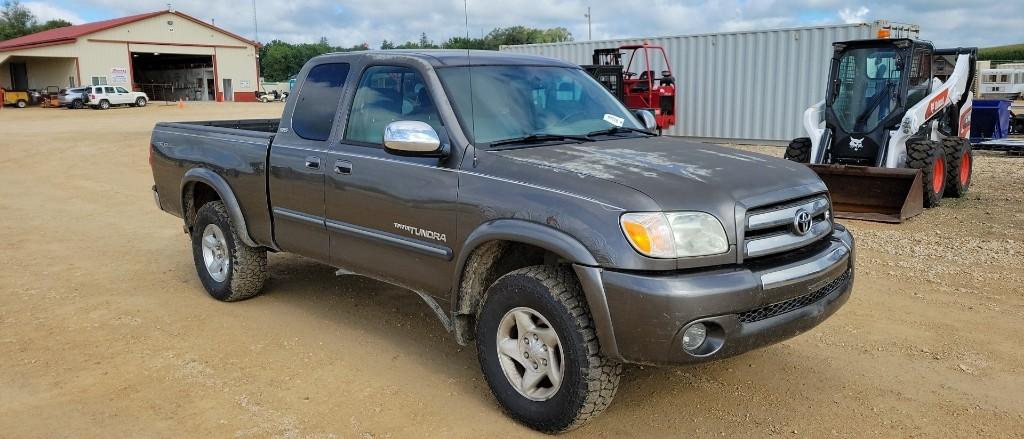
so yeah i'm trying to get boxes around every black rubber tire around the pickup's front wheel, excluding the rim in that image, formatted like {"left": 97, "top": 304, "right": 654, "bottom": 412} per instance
{"left": 476, "top": 265, "right": 623, "bottom": 433}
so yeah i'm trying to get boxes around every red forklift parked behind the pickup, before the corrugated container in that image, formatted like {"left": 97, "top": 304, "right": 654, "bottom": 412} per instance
{"left": 583, "top": 42, "right": 676, "bottom": 133}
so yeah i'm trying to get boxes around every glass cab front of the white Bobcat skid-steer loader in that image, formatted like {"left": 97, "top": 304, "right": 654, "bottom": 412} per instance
{"left": 833, "top": 47, "right": 902, "bottom": 133}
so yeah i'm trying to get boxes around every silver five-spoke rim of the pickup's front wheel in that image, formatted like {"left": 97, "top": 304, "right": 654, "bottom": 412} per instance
{"left": 497, "top": 307, "right": 565, "bottom": 401}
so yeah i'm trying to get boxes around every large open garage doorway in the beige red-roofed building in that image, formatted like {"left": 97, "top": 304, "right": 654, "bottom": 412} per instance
{"left": 131, "top": 52, "right": 217, "bottom": 101}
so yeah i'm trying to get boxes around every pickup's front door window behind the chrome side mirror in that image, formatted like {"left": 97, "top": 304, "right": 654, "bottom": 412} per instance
{"left": 345, "top": 65, "right": 441, "bottom": 145}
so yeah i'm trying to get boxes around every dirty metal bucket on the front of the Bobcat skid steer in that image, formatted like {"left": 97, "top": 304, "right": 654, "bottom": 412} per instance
{"left": 808, "top": 165, "right": 925, "bottom": 223}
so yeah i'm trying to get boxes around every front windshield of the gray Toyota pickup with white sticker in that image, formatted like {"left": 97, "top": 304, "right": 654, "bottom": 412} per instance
{"left": 437, "top": 65, "right": 643, "bottom": 144}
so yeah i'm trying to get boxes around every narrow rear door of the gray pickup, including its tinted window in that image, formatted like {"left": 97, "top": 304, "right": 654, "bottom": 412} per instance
{"left": 269, "top": 63, "right": 348, "bottom": 263}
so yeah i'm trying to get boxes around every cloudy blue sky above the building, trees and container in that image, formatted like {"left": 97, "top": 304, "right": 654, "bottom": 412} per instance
{"left": 23, "top": 0, "right": 1024, "bottom": 47}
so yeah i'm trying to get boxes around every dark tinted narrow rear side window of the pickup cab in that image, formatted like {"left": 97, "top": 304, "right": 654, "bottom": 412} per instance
{"left": 292, "top": 62, "right": 348, "bottom": 140}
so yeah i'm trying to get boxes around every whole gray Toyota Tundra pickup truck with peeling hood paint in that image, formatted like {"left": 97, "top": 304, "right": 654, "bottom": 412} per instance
{"left": 151, "top": 51, "right": 854, "bottom": 432}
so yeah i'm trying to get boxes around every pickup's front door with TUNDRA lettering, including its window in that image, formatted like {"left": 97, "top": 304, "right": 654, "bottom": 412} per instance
{"left": 327, "top": 65, "right": 459, "bottom": 300}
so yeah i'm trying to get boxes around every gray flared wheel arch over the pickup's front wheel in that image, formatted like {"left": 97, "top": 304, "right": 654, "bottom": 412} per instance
{"left": 451, "top": 219, "right": 621, "bottom": 358}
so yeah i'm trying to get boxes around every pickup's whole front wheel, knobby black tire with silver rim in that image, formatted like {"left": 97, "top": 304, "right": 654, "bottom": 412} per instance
{"left": 476, "top": 266, "right": 623, "bottom": 433}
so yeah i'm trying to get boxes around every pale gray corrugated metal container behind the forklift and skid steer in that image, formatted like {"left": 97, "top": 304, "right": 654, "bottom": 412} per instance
{"left": 501, "top": 21, "right": 919, "bottom": 143}
